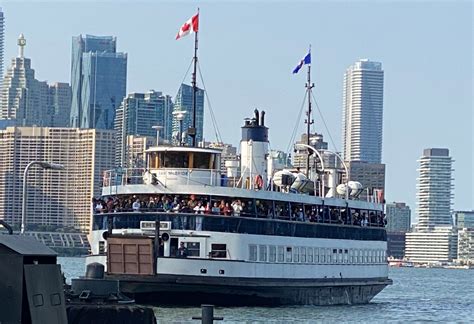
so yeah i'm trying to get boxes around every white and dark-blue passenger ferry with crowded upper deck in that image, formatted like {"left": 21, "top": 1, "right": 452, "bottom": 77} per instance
{"left": 86, "top": 111, "right": 391, "bottom": 306}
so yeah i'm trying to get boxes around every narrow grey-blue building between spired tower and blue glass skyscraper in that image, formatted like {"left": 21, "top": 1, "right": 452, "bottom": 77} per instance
{"left": 47, "top": 82, "right": 72, "bottom": 127}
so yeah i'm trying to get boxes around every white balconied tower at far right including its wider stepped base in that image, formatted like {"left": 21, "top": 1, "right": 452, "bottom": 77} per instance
{"left": 405, "top": 148, "right": 458, "bottom": 262}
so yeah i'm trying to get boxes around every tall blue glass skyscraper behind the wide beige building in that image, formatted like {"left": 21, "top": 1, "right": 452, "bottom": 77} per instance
{"left": 70, "top": 35, "right": 127, "bottom": 129}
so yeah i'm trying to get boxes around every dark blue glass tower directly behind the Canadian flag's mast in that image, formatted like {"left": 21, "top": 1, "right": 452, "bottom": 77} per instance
{"left": 172, "top": 83, "right": 204, "bottom": 144}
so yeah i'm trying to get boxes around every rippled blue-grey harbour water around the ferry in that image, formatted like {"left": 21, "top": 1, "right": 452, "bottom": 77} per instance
{"left": 58, "top": 258, "right": 474, "bottom": 324}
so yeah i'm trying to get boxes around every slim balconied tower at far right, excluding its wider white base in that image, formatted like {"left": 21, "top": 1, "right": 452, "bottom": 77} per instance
{"left": 417, "top": 148, "right": 454, "bottom": 230}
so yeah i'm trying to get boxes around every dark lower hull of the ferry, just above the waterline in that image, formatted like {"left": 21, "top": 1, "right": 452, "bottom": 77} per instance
{"left": 108, "top": 275, "right": 392, "bottom": 306}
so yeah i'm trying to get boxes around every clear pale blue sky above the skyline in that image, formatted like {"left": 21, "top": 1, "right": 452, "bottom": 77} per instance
{"left": 0, "top": 0, "right": 474, "bottom": 220}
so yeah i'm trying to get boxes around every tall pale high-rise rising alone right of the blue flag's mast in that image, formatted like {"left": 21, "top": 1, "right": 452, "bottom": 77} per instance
{"left": 342, "top": 59, "right": 384, "bottom": 163}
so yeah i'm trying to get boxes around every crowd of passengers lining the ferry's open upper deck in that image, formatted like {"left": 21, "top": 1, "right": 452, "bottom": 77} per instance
{"left": 92, "top": 195, "right": 386, "bottom": 227}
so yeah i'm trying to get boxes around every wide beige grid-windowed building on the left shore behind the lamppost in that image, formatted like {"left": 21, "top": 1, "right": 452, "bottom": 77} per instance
{"left": 0, "top": 127, "right": 114, "bottom": 232}
